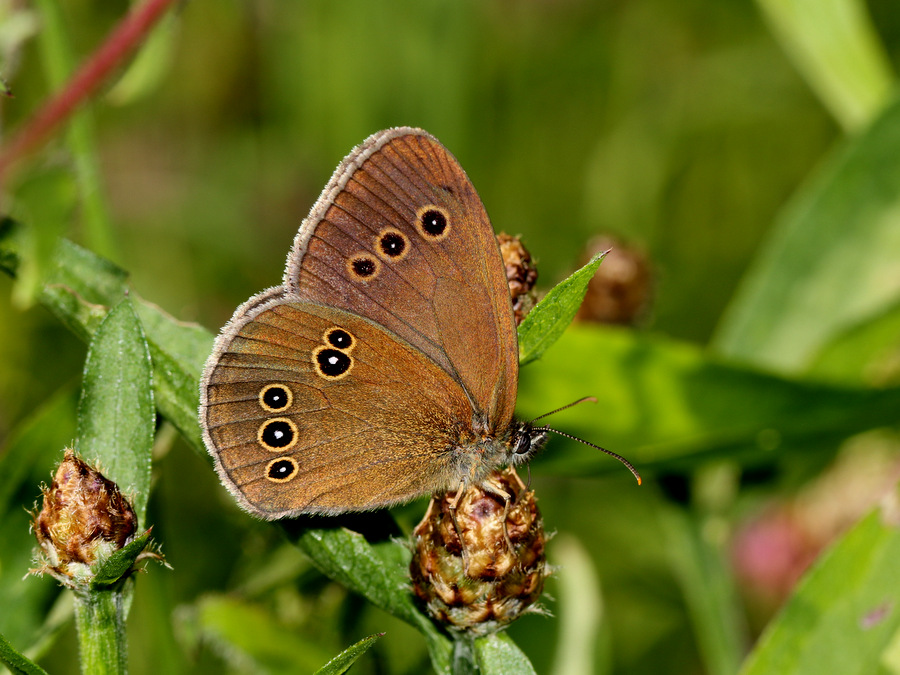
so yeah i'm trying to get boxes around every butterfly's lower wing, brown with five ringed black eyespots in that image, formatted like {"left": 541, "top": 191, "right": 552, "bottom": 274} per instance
{"left": 202, "top": 293, "right": 471, "bottom": 518}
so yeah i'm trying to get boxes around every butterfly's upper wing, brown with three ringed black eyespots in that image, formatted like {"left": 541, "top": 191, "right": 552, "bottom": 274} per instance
{"left": 285, "top": 129, "right": 518, "bottom": 429}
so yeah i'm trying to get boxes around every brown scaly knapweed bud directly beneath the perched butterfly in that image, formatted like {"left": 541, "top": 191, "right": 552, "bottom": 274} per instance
{"left": 410, "top": 468, "right": 547, "bottom": 636}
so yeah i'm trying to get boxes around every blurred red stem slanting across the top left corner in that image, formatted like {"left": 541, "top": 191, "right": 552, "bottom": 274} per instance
{"left": 0, "top": 0, "right": 176, "bottom": 189}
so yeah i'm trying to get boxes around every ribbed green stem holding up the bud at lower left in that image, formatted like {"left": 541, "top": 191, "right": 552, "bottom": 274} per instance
{"left": 75, "top": 589, "right": 128, "bottom": 675}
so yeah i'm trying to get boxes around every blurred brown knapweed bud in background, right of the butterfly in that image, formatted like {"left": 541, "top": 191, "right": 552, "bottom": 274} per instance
{"left": 575, "top": 236, "right": 653, "bottom": 325}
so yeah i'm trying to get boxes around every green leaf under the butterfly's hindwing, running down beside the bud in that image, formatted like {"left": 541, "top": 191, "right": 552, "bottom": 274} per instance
{"left": 296, "top": 528, "right": 452, "bottom": 675}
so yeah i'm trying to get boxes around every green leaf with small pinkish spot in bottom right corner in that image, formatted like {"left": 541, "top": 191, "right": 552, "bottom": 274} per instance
{"left": 741, "top": 510, "right": 900, "bottom": 675}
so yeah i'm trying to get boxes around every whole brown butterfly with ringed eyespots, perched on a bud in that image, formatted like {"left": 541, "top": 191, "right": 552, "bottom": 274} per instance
{"left": 200, "top": 128, "right": 546, "bottom": 518}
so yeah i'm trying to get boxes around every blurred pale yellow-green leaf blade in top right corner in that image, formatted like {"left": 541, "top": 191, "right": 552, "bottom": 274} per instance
{"left": 757, "top": 0, "right": 894, "bottom": 130}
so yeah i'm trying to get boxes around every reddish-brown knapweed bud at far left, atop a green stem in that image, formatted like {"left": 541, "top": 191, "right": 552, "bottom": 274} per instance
{"left": 32, "top": 449, "right": 137, "bottom": 588}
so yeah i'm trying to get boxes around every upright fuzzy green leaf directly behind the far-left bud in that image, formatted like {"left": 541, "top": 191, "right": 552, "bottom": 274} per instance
{"left": 75, "top": 298, "right": 156, "bottom": 523}
